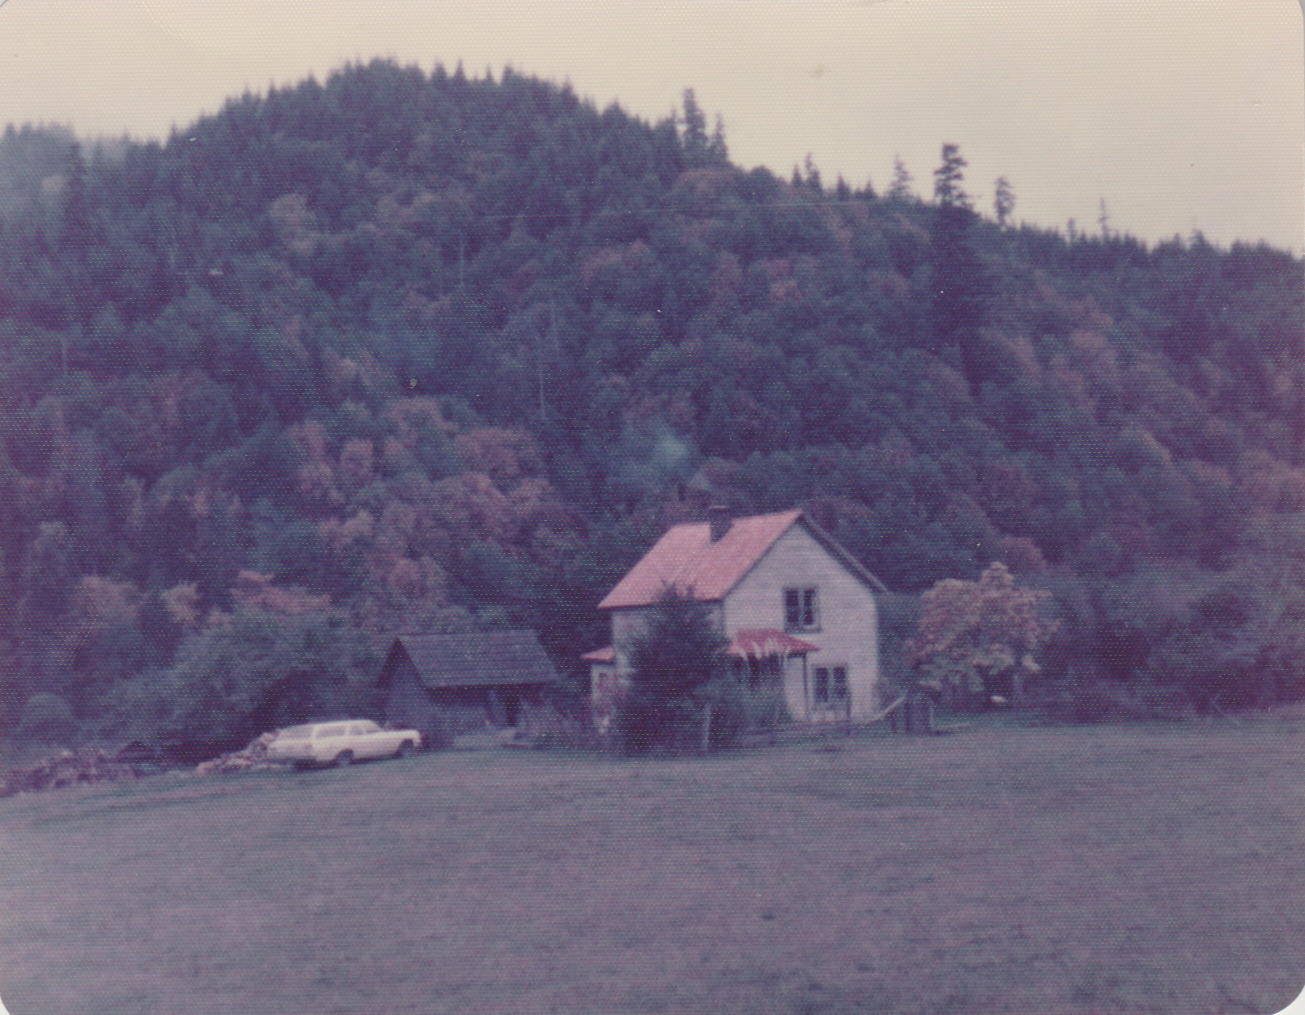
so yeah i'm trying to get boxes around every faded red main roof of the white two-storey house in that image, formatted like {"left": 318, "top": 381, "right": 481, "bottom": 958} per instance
{"left": 598, "top": 510, "right": 803, "bottom": 609}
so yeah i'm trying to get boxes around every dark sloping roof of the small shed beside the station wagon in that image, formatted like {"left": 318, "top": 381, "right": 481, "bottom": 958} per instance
{"left": 381, "top": 631, "right": 557, "bottom": 690}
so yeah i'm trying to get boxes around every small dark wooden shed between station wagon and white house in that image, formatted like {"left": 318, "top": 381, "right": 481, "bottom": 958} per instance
{"left": 378, "top": 630, "right": 557, "bottom": 742}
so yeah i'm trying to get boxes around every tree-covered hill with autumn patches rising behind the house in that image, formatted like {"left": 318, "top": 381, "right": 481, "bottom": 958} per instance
{"left": 0, "top": 63, "right": 1305, "bottom": 737}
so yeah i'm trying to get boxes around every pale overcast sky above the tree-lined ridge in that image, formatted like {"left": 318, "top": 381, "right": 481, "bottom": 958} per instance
{"left": 0, "top": 0, "right": 1305, "bottom": 256}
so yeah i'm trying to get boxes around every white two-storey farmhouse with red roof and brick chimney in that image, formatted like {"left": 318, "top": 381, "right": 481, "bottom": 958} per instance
{"left": 583, "top": 508, "right": 887, "bottom": 727}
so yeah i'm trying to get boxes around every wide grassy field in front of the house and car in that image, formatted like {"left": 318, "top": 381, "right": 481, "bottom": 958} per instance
{"left": 0, "top": 720, "right": 1305, "bottom": 1015}
